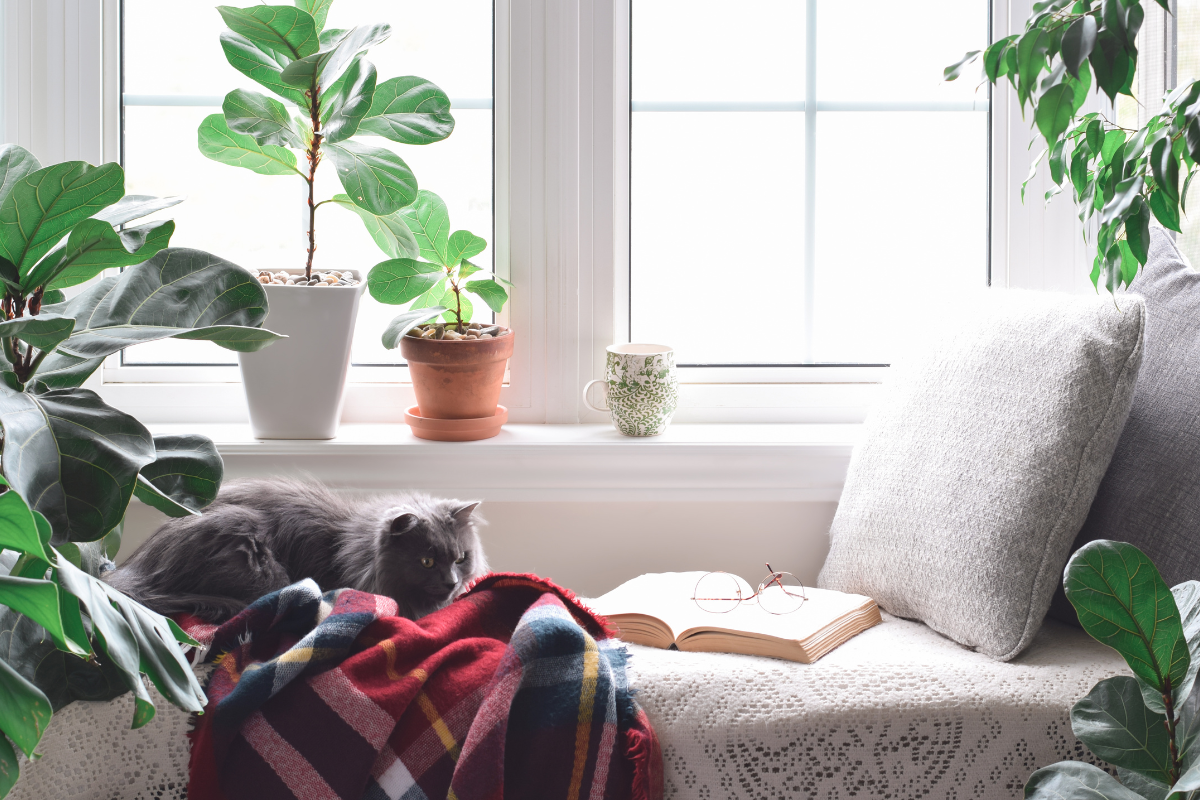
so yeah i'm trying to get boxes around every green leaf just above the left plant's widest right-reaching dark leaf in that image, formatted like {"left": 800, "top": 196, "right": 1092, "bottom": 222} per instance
{"left": 22, "top": 219, "right": 175, "bottom": 293}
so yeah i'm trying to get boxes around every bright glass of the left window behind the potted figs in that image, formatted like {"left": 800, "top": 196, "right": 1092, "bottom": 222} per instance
{"left": 122, "top": 0, "right": 494, "bottom": 369}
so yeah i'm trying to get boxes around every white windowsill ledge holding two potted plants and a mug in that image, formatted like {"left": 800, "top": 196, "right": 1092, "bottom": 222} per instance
{"left": 150, "top": 423, "right": 862, "bottom": 503}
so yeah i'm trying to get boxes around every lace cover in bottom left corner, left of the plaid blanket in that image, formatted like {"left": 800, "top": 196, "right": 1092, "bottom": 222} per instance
{"left": 7, "top": 666, "right": 211, "bottom": 800}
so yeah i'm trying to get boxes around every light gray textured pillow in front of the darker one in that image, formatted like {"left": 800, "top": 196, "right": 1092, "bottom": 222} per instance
{"left": 818, "top": 289, "right": 1145, "bottom": 661}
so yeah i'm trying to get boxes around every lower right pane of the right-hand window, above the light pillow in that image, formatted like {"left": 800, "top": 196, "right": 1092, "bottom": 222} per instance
{"left": 812, "top": 113, "right": 988, "bottom": 363}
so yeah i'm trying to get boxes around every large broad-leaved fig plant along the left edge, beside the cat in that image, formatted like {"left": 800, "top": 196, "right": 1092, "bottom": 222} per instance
{"left": 0, "top": 145, "right": 281, "bottom": 796}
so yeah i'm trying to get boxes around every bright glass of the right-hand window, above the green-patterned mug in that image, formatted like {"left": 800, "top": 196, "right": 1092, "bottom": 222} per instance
{"left": 629, "top": 0, "right": 988, "bottom": 365}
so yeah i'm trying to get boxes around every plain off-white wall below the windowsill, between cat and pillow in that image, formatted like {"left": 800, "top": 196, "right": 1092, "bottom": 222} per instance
{"left": 118, "top": 501, "right": 836, "bottom": 596}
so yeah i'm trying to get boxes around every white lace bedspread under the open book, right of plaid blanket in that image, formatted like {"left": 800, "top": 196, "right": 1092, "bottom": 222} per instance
{"left": 630, "top": 615, "right": 1128, "bottom": 800}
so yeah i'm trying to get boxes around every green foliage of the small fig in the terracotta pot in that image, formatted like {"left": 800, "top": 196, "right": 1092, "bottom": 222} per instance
{"left": 367, "top": 190, "right": 512, "bottom": 349}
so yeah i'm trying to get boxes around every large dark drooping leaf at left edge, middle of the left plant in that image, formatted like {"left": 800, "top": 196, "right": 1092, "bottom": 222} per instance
{"left": 0, "top": 389, "right": 154, "bottom": 542}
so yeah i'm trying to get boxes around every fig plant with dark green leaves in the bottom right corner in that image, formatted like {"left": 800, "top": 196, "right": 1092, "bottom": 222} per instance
{"left": 1025, "top": 541, "right": 1200, "bottom": 800}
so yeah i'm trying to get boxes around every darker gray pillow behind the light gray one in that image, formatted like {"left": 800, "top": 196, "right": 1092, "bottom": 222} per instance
{"left": 1050, "top": 228, "right": 1200, "bottom": 625}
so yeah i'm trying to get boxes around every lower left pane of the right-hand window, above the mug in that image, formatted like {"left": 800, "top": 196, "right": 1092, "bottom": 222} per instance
{"left": 630, "top": 112, "right": 804, "bottom": 363}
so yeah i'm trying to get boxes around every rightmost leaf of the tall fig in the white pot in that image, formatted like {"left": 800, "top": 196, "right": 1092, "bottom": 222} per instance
{"left": 359, "top": 76, "right": 454, "bottom": 144}
